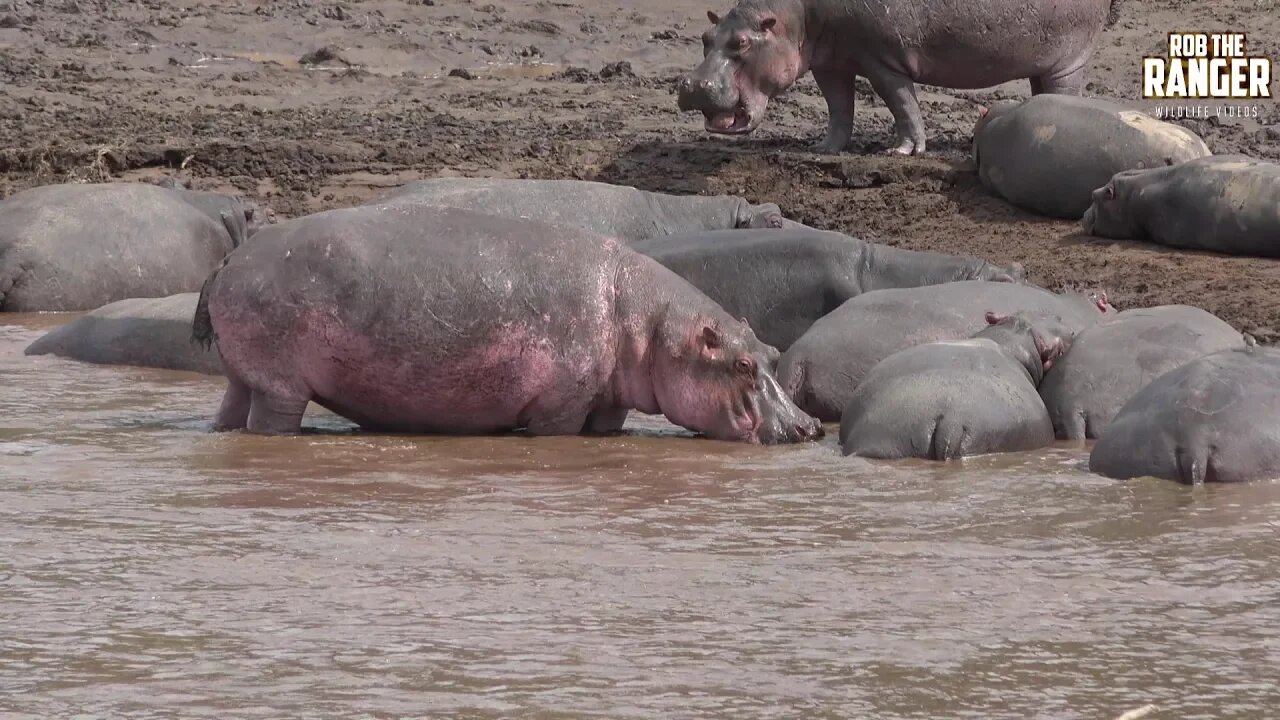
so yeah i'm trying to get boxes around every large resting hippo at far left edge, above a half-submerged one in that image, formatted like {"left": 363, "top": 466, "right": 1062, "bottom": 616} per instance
{"left": 0, "top": 182, "right": 243, "bottom": 313}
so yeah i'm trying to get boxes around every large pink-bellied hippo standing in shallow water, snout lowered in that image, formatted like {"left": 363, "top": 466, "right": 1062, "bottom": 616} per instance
{"left": 192, "top": 198, "right": 822, "bottom": 445}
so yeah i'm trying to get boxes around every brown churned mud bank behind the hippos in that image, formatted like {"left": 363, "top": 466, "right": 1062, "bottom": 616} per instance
{"left": 0, "top": 0, "right": 1280, "bottom": 341}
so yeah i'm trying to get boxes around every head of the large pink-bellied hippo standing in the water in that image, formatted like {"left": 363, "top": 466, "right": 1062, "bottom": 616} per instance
{"left": 652, "top": 316, "right": 823, "bottom": 445}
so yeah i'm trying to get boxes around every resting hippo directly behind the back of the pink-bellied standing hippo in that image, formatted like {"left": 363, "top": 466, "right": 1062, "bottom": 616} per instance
{"left": 371, "top": 178, "right": 790, "bottom": 242}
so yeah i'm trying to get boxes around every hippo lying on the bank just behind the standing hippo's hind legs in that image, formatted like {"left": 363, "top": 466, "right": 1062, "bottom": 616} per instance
{"left": 973, "top": 95, "right": 1210, "bottom": 220}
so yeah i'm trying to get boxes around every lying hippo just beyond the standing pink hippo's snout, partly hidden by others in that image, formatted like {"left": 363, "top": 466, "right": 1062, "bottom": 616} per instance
{"left": 778, "top": 281, "right": 1115, "bottom": 421}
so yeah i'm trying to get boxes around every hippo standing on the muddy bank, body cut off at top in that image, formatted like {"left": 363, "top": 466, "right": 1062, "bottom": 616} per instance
{"left": 677, "top": 0, "right": 1120, "bottom": 154}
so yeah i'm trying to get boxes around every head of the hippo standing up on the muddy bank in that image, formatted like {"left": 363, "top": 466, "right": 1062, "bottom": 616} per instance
{"left": 677, "top": 1, "right": 804, "bottom": 135}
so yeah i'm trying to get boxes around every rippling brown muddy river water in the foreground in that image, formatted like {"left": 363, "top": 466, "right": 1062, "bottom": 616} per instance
{"left": 0, "top": 316, "right": 1280, "bottom": 720}
